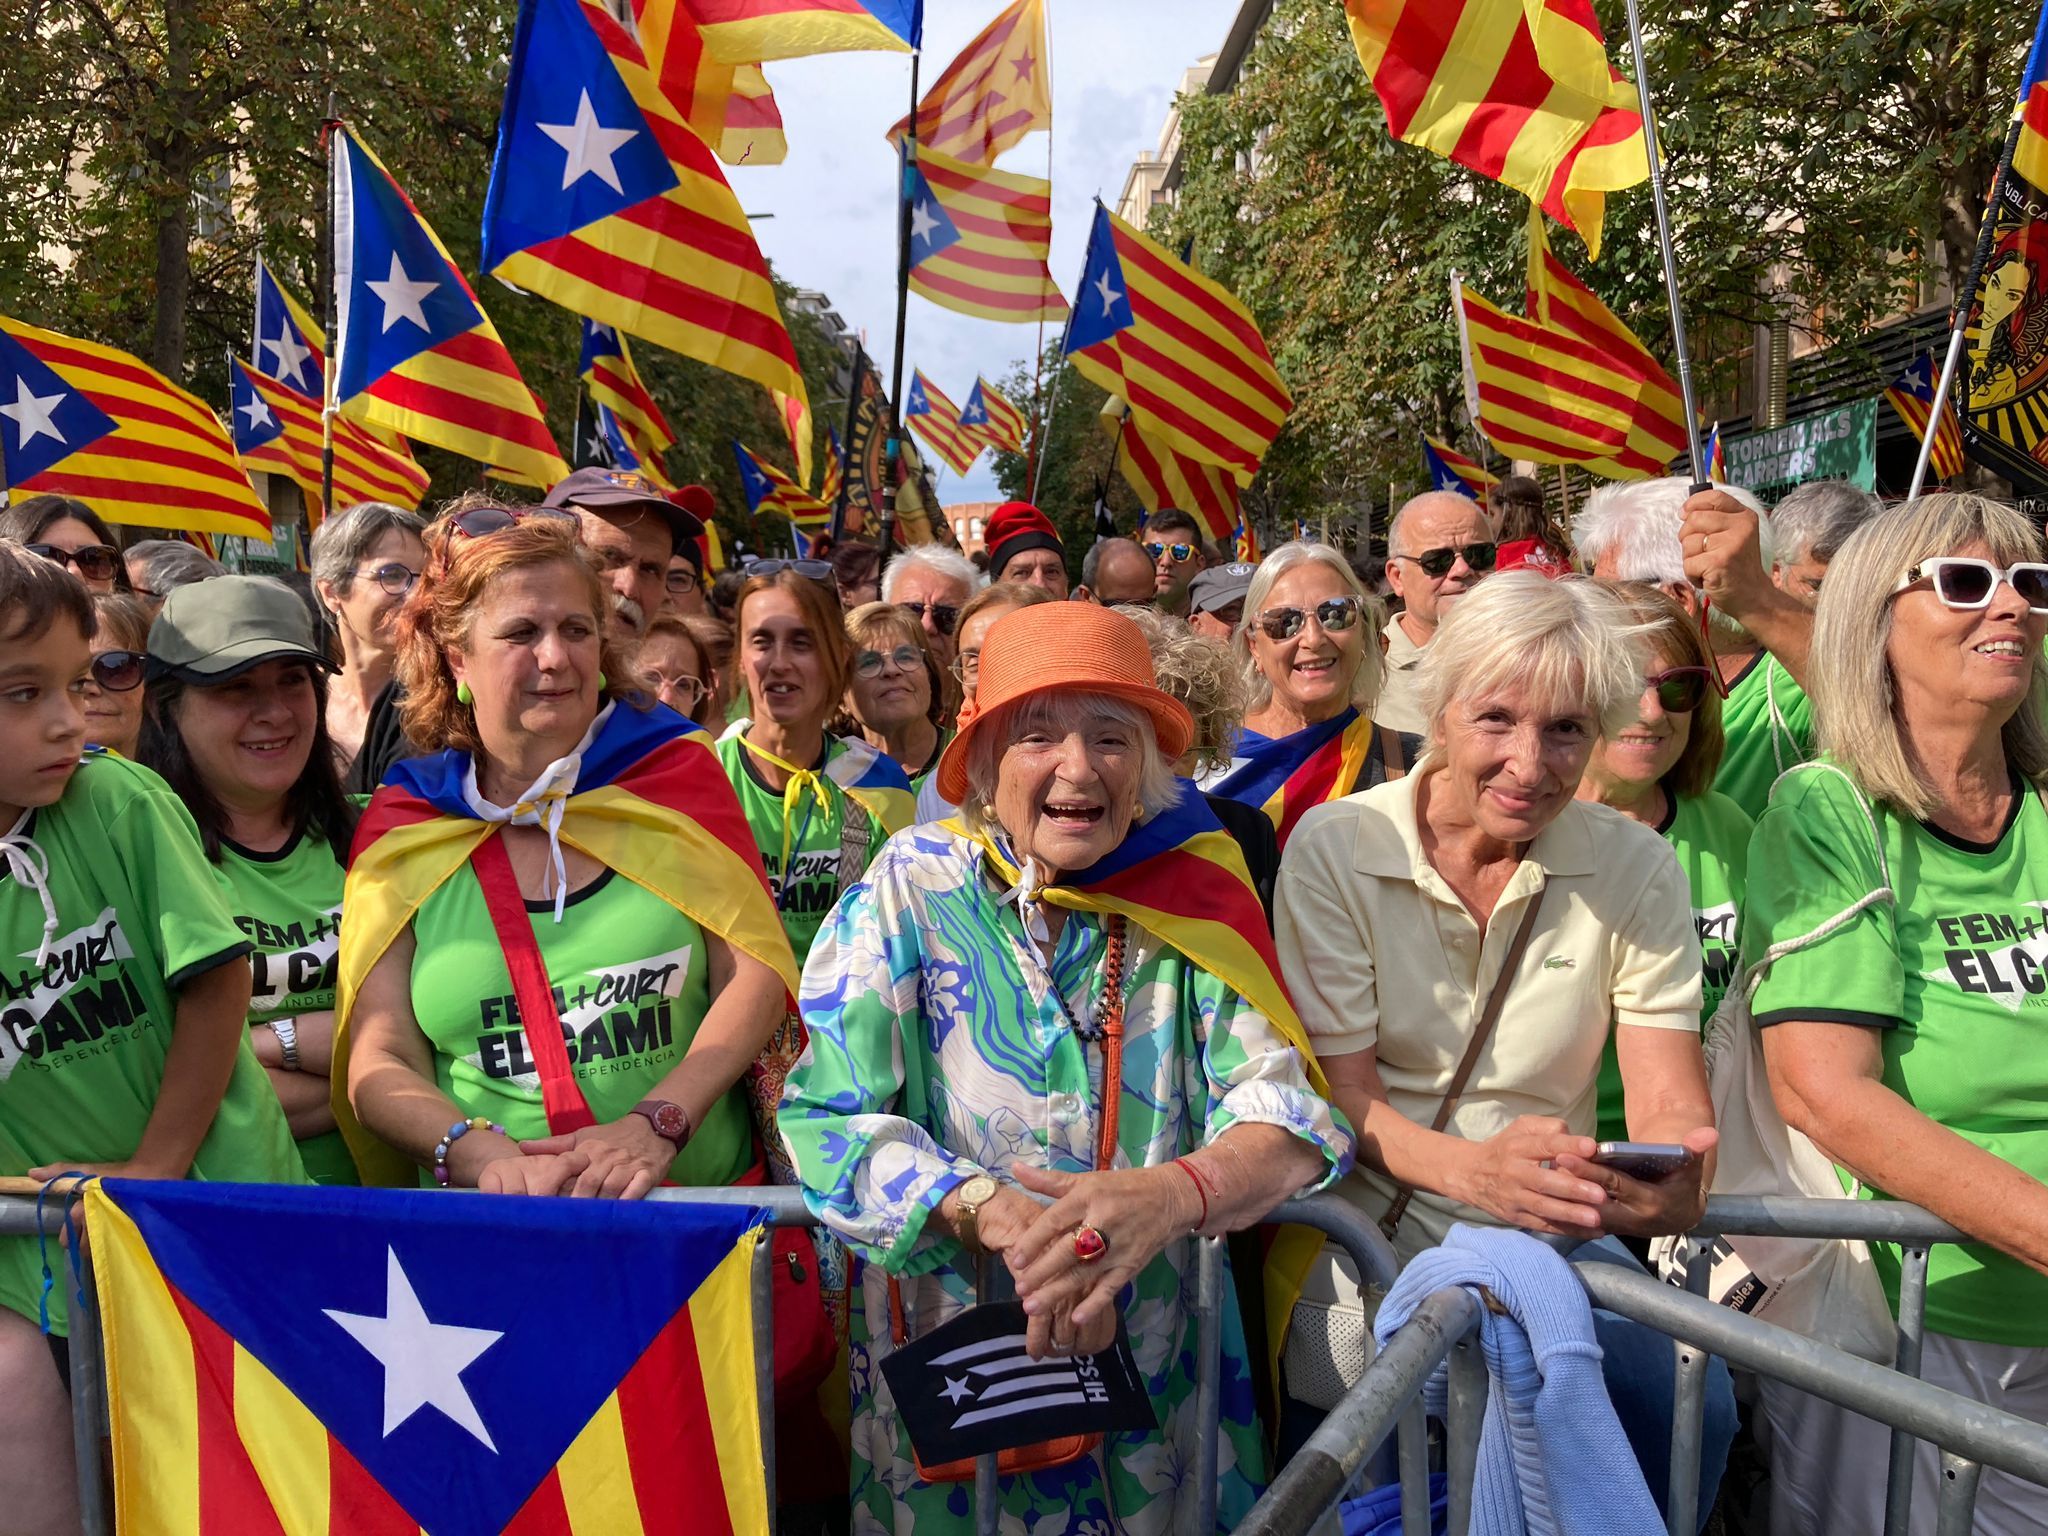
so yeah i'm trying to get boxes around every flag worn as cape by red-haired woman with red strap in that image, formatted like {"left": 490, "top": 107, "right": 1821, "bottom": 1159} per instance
{"left": 332, "top": 702, "right": 797, "bottom": 1184}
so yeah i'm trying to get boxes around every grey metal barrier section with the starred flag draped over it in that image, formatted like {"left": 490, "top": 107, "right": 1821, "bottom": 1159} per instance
{"left": 0, "top": 1186, "right": 1400, "bottom": 1536}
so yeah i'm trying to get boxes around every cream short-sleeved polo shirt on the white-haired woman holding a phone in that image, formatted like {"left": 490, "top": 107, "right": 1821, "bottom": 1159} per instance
{"left": 1274, "top": 774, "right": 1700, "bottom": 1257}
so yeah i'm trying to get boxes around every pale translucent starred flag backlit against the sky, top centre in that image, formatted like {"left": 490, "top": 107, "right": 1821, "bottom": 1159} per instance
{"left": 907, "top": 145, "right": 1067, "bottom": 322}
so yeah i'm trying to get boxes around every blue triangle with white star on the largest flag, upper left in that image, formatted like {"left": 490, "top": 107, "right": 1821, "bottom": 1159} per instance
{"left": 483, "top": 0, "right": 682, "bottom": 272}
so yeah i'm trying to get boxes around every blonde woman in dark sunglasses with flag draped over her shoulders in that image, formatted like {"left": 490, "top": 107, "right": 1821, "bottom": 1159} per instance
{"left": 1206, "top": 543, "right": 1407, "bottom": 850}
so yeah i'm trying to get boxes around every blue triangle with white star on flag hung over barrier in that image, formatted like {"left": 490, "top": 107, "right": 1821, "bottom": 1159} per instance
{"left": 106, "top": 1180, "right": 760, "bottom": 1536}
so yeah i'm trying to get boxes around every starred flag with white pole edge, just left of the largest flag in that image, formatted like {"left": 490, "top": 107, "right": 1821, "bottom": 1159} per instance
{"left": 334, "top": 125, "right": 569, "bottom": 487}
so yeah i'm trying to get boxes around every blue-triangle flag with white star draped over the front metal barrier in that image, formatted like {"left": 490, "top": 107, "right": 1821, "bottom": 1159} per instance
{"left": 84, "top": 1180, "right": 768, "bottom": 1536}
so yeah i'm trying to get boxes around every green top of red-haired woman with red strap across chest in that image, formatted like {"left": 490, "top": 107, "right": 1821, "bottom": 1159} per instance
{"left": 412, "top": 866, "right": 754, "bottom": 1184}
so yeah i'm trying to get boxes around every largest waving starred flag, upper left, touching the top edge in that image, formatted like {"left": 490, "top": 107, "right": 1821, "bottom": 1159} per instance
{"left": 483, "top": 0, "right": 811, "bottom": 487}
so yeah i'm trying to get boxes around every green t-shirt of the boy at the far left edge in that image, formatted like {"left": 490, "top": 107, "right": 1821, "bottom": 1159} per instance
{"left": 0, "top": 752, "right": 305, "bottom": 1333}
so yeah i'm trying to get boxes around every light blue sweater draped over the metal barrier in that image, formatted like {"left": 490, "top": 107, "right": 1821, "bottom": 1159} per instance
{"left": 1372, "top": 1225, "right": 1663, "bottom": 1536}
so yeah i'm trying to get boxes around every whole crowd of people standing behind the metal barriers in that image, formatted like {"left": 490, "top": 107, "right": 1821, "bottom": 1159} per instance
{"left": 0, "top": 469, "right": 2048, "bottom": 1536}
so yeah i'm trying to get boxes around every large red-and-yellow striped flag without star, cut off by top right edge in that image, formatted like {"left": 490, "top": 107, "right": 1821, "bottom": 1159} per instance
{"left": 1343, "top": 0, "right": 1651, "bottom": 258}
